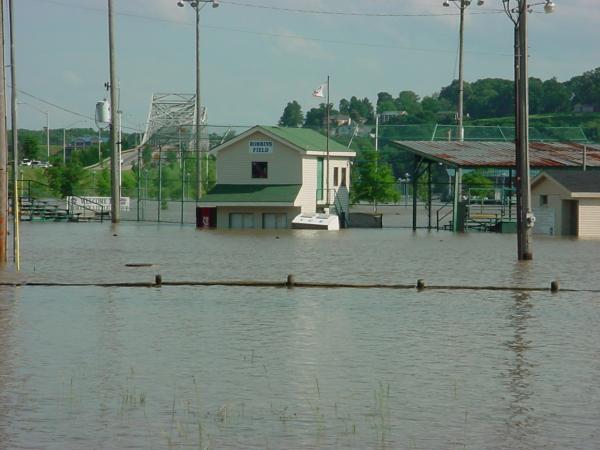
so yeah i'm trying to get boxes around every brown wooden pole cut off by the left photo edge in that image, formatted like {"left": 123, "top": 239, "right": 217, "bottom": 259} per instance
{"left": 0, "top": 0, "right": 8, "bottom": 266}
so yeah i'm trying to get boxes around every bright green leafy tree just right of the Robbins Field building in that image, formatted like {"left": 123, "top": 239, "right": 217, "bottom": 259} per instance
{"left": 351, "top": 150, "right": 400, "bottom": 212}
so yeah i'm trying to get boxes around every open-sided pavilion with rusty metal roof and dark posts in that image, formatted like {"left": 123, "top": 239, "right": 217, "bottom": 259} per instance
{"left": 392, "top": 141, "right": 600, "bottom": 230}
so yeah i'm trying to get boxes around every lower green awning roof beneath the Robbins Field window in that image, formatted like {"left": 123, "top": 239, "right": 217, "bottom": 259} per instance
{"left": 200, "top": 184, "right": 301, "bottom": 203}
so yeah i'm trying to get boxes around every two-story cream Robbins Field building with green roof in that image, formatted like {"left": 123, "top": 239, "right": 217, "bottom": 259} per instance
{"left": 199, "top": 126, "right": 355, "bottom": 228}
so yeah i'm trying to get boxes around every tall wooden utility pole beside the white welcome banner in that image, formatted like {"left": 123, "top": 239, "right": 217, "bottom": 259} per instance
{"left": 108, "top": 0, "right": 121, "bottom": 223}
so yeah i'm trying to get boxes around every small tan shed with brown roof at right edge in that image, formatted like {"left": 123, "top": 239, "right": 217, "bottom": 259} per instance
{"left": 531, "top": 170, "right": 600, "bottom": 237}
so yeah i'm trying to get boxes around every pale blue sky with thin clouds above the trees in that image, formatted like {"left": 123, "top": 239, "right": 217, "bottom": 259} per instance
{"left": 5, "top": 0, "right": 600, "bottom": 131}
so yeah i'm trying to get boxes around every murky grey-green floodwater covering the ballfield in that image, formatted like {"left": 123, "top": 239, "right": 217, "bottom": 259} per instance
{"left": 0, "top": 223, "right": 600, "bottom": 450}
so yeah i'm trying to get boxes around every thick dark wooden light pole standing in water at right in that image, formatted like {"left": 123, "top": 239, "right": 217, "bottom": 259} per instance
{"left": 502, "top": 0, "right": 556, "bottom": 260}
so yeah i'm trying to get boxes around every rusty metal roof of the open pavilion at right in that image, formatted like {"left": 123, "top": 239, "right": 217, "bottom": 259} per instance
{"left": 393, "top": 141, "right": 600, "bottom": 169}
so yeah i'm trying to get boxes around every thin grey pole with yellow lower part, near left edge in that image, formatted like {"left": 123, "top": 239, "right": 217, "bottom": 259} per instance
{"left": 8, "top": 0, "right": 21, "bottom": 271}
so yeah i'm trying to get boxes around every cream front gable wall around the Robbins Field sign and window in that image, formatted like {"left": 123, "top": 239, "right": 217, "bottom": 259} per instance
{"left": 217, "top": 132, "right": 302, "bottom": 184}
